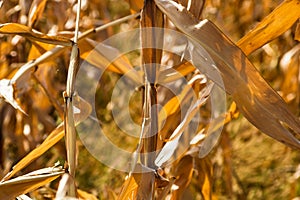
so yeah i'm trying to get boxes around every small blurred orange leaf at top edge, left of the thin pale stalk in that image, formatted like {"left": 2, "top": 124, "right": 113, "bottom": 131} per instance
{"left": 28, "top": 0, "right": 47, "bottom": 27}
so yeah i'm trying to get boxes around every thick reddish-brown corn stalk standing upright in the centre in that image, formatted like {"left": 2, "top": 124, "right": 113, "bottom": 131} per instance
{"left": 141, "top": 0, "right": 164, "bottom": 168}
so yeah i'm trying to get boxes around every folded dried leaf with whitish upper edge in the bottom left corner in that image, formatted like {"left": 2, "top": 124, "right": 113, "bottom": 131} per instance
{"left": 0, "top": 167, "right": 64, "bottom": 199}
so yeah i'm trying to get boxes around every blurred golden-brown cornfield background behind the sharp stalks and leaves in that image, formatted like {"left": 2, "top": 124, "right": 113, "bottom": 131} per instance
{"left": 0, "top": 0, "right": 300, "bottom": 199}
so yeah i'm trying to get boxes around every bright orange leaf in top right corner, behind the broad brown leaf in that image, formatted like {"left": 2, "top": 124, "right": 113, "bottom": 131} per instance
{"left": 237, "top": 0, "right": 300, "bottom": 55}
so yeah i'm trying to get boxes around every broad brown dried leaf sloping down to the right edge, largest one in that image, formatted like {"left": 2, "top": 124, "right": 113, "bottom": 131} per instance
{"left": 156, "top": 0, "right": 300, "bottom": 149}
